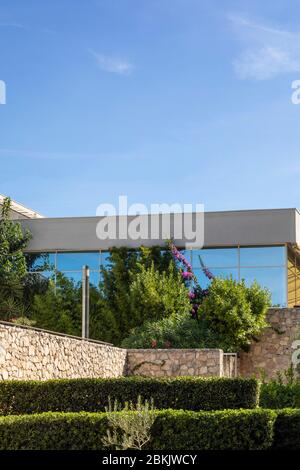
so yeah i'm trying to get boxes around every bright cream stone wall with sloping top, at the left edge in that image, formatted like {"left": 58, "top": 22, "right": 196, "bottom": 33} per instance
{"left": 0, "top": 322, "right": 127, "bottom": 380}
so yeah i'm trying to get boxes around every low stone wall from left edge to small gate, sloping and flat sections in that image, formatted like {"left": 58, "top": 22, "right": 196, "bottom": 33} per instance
{"left": 0, "top": 322, "right": 235, "bottom": 380}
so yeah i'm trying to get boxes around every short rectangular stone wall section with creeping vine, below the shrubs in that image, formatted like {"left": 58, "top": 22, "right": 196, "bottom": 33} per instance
{"left": 127, "top": 349, "right": 223, "bottom": 377}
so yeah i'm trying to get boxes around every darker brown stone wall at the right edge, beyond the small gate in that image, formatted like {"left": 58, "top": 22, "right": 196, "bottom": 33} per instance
{"left": 239, "top": 308, "right": 300, "bottom": 377}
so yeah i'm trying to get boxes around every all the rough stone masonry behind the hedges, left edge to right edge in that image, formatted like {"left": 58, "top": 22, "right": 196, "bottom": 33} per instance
{"left": 0, "top": 308, "right": 300, "bottom": 380}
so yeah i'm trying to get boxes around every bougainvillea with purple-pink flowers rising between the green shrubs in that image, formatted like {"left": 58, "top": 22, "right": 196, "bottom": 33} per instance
{"left": 170, "top": 242, "right": 214, "bottom": 319}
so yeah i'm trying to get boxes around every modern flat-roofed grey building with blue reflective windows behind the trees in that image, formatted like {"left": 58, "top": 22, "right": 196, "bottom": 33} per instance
{"left": 4, "top": 196, "right": 300, "bottom": 307}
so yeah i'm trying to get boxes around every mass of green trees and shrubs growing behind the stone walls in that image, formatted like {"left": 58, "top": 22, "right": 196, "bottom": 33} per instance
{"left": 0, "top": 199, "right": 270, "bottom": 351}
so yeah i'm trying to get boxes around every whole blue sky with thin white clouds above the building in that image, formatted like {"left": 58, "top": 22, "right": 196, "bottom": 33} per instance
{"left": 0, "top": 0, "right": 300, "bottom": 216}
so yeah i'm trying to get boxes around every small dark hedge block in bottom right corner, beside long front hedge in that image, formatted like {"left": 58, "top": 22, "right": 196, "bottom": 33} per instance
{"left": 273, "top": 409, "right": 300, "bottom": 450}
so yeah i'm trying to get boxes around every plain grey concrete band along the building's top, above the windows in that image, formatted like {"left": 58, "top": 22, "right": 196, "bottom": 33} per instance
{"left": 21, "top": 209, "right": 300, "bottom": 251}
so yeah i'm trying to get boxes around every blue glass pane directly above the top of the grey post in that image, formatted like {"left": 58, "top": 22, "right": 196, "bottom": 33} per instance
{"left": 57, "top": 251, "right": 100, "bottom": 271}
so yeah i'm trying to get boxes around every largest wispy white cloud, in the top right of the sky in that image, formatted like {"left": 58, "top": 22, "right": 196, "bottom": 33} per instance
{"left": 228, "top": 15, "right": 300, "bottom": 80}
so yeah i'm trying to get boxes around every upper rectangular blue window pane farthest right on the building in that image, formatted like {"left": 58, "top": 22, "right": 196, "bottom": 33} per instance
{"left": 240, "top": 246, "right": 286, "bottom": 266}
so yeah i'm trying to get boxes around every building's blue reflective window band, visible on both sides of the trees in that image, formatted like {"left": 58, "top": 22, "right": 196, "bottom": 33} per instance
{"left": 26, "top": 246, "right": 288, "bottom": 306}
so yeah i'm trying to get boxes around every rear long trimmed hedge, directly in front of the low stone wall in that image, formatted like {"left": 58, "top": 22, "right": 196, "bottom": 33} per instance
{"left": 0, "top": 377, "right": 259, "bottom": 415}
